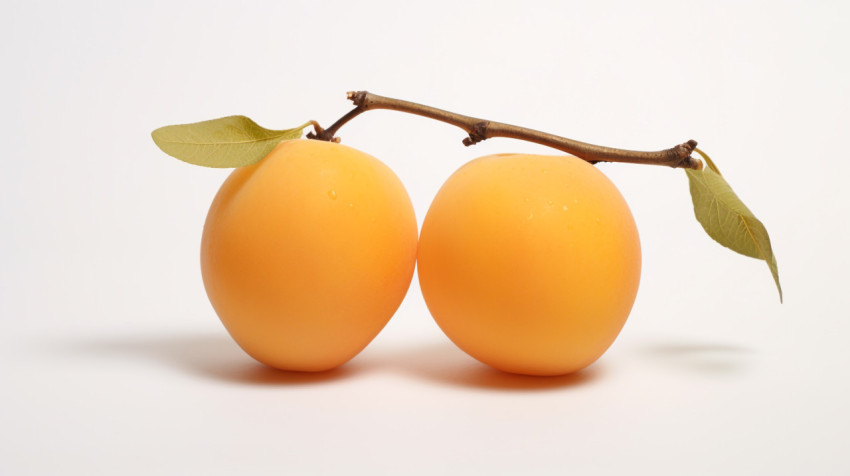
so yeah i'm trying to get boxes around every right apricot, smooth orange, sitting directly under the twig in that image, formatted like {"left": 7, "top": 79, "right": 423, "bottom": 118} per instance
{"left": 418, "top": 154, "right": 641, "bottom": 376}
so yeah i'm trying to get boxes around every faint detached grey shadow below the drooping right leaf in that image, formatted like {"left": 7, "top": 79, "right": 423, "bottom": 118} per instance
{"left": 638, "top": 343, "right": 754, "bottom": 375}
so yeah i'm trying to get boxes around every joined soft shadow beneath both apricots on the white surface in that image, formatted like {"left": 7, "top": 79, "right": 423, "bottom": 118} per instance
{"left": 60, "top": 334, "right": 600, "bottom": 391}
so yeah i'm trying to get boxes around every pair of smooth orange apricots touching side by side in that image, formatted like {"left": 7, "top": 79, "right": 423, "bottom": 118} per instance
{"left": 201, "top": 140, "right": 640, "bottom": 375}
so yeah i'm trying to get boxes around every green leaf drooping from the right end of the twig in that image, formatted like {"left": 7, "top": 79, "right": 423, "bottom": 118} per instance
{"left": 685, "top": 150, "right": 782, "bottom": 302}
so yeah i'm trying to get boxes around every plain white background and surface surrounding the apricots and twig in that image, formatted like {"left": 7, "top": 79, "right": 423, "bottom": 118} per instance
{"left": 0, "top": 0, "right": 850, "bottom": 475}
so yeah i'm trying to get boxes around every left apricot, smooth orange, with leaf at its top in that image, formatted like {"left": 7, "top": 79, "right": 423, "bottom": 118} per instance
{"left": 201, "top": 140, "right": 417, "bottom": 371}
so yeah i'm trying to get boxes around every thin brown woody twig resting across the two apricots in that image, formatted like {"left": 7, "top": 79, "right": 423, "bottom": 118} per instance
{"left": 307, "top": 91, "right": 702, "bottom": 170}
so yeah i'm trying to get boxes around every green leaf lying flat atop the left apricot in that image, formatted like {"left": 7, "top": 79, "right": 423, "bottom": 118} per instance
{"left": 151, "top": 116, "right": 310, "bottom": 168}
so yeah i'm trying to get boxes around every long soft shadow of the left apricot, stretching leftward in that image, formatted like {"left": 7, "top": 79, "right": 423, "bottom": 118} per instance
{"left": 66, "top": 334, "right": 353, "bottom": 385}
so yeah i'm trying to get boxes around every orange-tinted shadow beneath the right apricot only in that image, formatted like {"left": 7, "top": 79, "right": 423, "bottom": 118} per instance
{"left": 359, "top": 341, "right": 601, "bottom": 391}
